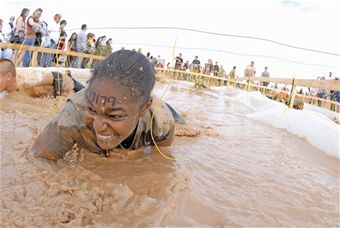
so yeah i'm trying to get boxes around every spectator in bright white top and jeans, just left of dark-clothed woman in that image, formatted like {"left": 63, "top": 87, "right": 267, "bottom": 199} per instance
{"left": 41, "top": 14, "right": 61, "bottom": 67}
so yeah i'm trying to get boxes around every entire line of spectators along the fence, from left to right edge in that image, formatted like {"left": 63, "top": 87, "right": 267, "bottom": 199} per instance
{"left": 0, "top": 8, "right": 340, "bottom": 105}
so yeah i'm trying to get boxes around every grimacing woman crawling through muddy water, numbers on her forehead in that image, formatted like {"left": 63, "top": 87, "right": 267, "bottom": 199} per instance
{"left": 32, "top": 50, "right": 180, "bottom": 160}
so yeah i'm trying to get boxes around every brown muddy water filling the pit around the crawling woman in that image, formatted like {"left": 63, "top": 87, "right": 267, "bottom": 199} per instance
{"left": 1, "top": 78, "right": 340, "bottom": 227}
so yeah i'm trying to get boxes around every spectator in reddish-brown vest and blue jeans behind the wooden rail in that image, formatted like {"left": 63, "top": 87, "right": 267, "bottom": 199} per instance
{"left": 23, "top": 8, "right": 42, "bottom": 67}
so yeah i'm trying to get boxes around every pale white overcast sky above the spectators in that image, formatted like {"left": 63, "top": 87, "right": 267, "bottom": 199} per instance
{"left": 0, "top": 0, "right": 340, "bottom": 79}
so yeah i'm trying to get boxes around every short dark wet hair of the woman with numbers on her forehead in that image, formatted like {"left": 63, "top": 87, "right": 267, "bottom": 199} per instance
{"left": 89, "top": 50, "right": 155, "bottom": 104}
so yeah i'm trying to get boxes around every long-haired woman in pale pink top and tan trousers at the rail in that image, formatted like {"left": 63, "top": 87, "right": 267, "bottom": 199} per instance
{"left": 12, "top": 8, "right": 30, "bottom": 66}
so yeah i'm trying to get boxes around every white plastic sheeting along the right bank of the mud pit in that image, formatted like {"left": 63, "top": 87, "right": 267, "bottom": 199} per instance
{"left": 213, "top": 87, "right": 340, "bottom": 159}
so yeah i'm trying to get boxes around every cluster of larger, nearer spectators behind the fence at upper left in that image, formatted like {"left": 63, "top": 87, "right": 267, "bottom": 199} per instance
{"left": 0, "top": 8, "right": 112, "bottom": 68}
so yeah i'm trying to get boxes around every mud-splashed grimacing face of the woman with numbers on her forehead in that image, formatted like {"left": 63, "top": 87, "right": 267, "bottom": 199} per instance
{"left": 87, "top": 79, "right": 143, "bottom": 150}
